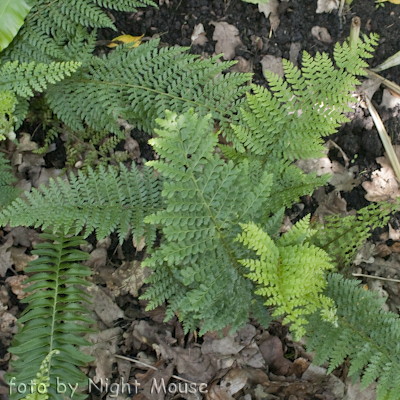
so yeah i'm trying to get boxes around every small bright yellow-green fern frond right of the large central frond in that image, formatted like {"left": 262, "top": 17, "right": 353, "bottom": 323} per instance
{"left": 237, "top": 217, "right": 336, "bottom": 340}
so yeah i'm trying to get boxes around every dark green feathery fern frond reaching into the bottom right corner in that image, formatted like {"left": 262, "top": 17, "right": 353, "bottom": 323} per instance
{"left": 307, "top": 274, "right": 400, "bottom": 400}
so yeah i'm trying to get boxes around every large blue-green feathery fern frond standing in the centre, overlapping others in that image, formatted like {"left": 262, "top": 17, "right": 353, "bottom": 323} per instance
{"left": 143, "top": 110, "right": 272, "bottom": 334}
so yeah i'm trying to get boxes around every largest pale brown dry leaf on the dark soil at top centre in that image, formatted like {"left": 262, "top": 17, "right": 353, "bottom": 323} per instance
{"left": 210, "top": 21, "right": 243, "bottom": 60}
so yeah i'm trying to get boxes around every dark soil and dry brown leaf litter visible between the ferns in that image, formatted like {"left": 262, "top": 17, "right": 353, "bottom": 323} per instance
{"left": 0, "top": 0, "right": 400, "bottom": 400}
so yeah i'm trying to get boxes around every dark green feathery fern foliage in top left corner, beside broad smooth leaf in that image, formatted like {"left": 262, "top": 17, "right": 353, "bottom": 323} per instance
{"left": 1, "top": 0, "right": 156, "bottom": 64}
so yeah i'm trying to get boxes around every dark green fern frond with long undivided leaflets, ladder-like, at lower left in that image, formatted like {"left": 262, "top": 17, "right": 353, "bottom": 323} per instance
{"left": 7, "top": 233, "right": 94, "bottom": 400}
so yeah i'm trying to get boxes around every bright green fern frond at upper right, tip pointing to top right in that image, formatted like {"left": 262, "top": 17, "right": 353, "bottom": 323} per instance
{"left": 233, "top": 35, "right": 375, "bottom": 162}
